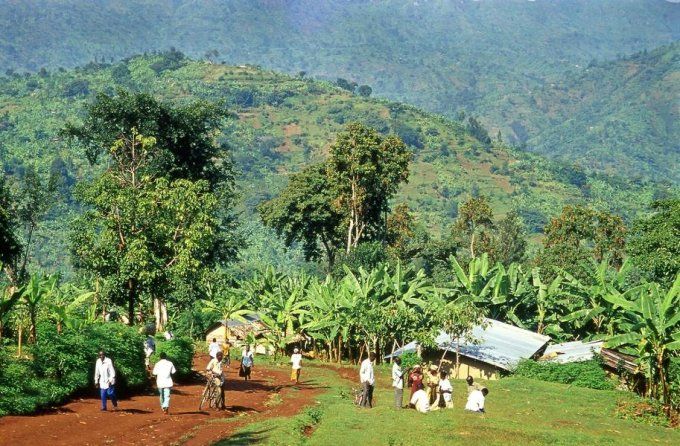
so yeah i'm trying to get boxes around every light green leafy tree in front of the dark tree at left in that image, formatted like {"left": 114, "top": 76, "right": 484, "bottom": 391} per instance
{"left": 71, "top": 129, "right": 219, "bottom": 329}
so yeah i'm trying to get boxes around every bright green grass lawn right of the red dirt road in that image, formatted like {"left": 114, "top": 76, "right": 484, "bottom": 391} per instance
{"left": 219, "top": 363, "right": 680, "bottom": 446}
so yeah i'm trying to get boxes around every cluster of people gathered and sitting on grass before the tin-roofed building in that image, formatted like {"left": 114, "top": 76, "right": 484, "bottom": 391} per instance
{"left": 408, "top": 364, "right": 489, "bottom": 413}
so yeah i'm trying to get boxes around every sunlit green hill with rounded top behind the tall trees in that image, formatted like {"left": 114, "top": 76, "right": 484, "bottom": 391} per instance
{"left": 0, "top": 53, "right": 668, "bottom": 274}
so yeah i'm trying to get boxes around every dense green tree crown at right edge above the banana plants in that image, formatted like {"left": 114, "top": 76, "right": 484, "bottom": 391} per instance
{"left": 627, "top": 198, "right": 680, "bottom": 286}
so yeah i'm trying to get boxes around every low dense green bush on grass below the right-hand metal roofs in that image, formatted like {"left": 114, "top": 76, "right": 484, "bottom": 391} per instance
{"left": 514, "top": 360, "right": 614, "bottom": 390}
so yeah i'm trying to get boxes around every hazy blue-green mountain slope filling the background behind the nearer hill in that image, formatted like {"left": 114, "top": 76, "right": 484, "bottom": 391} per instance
{"left": 0, "top": 0, "right": 680, "bottom": 184}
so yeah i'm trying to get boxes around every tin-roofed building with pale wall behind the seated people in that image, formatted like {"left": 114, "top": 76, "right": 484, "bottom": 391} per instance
{"left": 387, "top": 319, "right": 550, "bottom": 379}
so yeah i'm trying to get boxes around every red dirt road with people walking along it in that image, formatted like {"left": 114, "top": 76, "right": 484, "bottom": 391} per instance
{"left": 0, "top": 356, "right": 319, "bottom": 446}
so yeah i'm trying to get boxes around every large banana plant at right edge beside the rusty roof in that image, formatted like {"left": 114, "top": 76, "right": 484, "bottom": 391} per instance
{"left": 605, "top": 274, "right": 680, "bottom": 410}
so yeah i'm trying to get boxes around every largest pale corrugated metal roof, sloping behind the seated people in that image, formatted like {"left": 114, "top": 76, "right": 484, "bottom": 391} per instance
{"left": 390, "top": 319, "right": 550, "bottom": 370}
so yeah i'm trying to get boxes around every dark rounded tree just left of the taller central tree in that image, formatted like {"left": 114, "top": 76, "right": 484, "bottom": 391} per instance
{"left": 258, "top": 164, "right": 343, "bottom": 268}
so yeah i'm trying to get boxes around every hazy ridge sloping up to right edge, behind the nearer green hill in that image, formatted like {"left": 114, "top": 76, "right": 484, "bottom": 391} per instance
{"left": 505, "top": 43, "right": 680, "bottom": 184}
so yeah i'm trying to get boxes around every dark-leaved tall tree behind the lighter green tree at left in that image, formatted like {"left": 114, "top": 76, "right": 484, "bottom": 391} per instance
{"left": 63, "top": 90, "right": 241, "bottom": 262}
